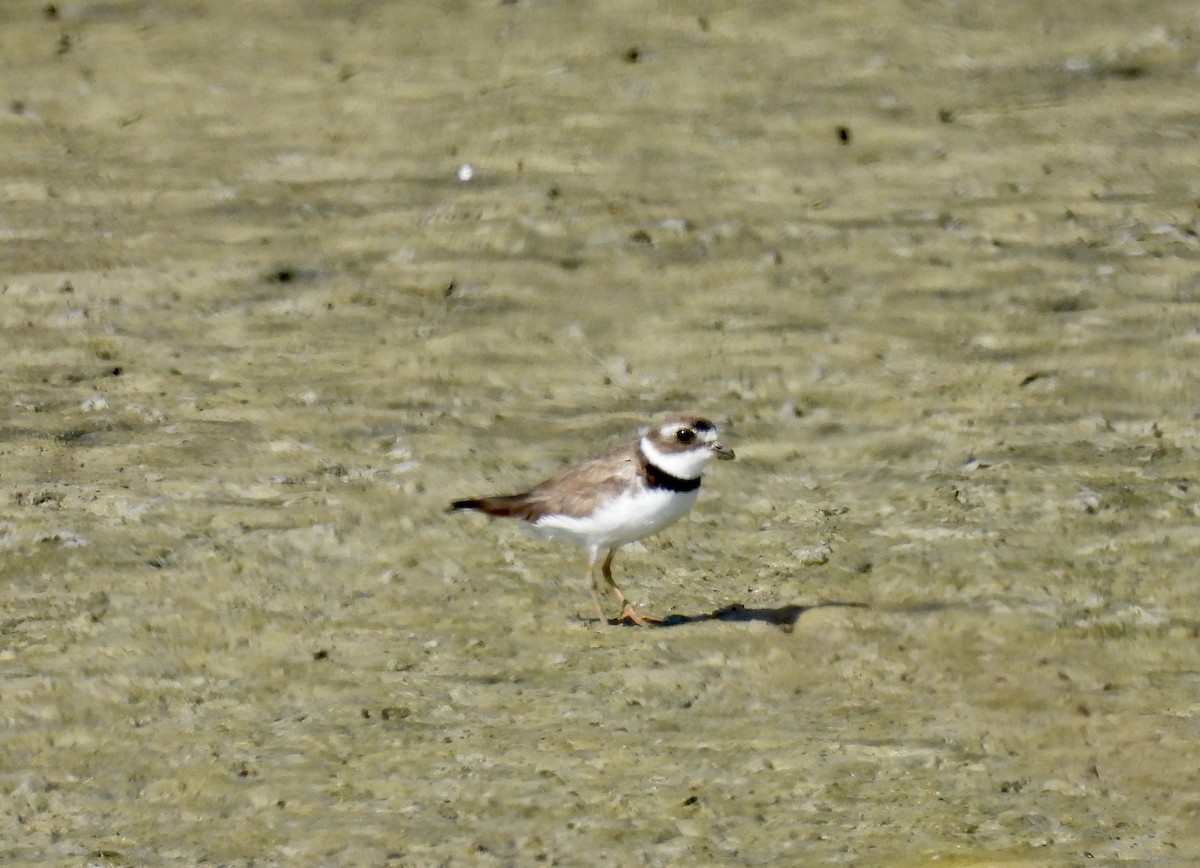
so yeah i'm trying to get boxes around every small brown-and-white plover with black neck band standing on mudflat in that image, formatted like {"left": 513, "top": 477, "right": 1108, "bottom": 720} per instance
{"left": 448, "top": 415, "right": 733, "bottom": 627}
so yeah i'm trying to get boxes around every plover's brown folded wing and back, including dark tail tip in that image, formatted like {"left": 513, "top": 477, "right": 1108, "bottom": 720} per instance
{"left": 450, "top": 443, "right": 642, "bottom": 521}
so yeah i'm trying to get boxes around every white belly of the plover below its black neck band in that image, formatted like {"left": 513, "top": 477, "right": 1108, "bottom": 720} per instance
{"left": 528, "top": 489, "right": 700, "bottom": 547}
